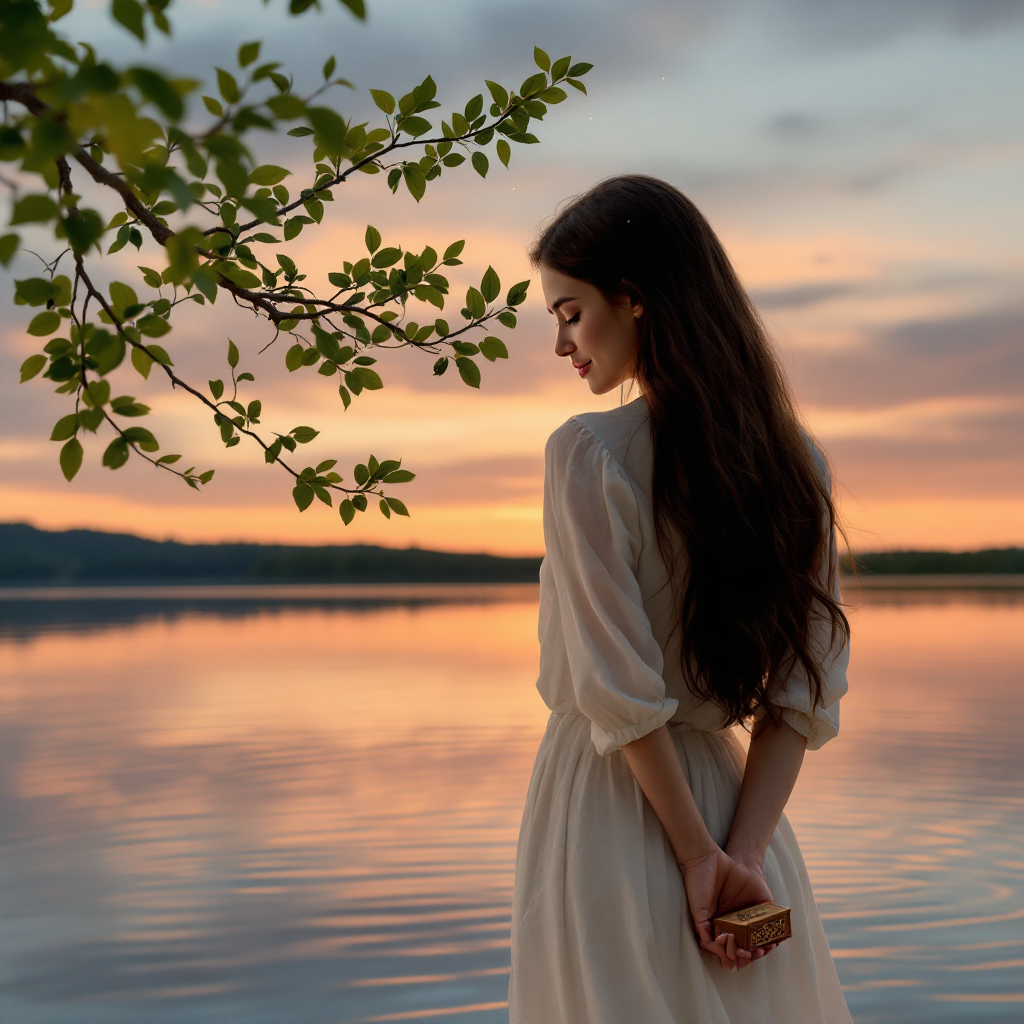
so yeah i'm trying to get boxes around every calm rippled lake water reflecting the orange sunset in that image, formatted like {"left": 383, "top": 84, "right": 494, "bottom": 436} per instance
{"left": 0, "top": 587, "right": 1024, "bottom": 1024}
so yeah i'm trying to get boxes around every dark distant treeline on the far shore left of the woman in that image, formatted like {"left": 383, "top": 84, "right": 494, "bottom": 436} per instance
{"left": 0, "top": 523, "right": 541, "bottom": 586}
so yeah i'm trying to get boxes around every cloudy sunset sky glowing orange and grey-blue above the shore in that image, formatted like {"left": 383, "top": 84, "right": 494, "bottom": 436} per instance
{"left": 0, "top": 0, "right": 1024, "bottom": 553}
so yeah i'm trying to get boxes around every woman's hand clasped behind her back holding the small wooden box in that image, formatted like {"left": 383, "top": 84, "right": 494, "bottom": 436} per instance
{"left": 679, "top": 846, "right": 774, "bottom": 970}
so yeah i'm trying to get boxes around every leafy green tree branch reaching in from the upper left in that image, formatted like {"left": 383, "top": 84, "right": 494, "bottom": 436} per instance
{"left": 0, "top": 0, "right": 591, "bottom": 524}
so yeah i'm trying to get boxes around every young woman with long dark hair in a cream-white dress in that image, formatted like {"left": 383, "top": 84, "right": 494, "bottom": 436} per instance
{"left": 509, "top": 175, "right": 851, "bottom": 1024}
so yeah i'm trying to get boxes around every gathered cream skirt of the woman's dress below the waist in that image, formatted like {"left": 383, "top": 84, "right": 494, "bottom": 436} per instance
{"left": 509, "top": 714, "right": 851, "bottom": 1024}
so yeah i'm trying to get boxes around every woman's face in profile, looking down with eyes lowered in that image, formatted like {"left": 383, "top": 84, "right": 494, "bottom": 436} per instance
{"left": 541, "top": 266, "right": 643, "bottom": 394}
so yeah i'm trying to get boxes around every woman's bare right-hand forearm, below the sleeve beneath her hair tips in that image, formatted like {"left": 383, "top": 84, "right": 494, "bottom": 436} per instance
{"left": 725, "top": 716, "right": 807, "bottom": 872}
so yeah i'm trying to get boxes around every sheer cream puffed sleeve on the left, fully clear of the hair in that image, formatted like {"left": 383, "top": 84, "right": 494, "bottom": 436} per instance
{"left": 544, "top": 420, "right": 678, "bottom": 755}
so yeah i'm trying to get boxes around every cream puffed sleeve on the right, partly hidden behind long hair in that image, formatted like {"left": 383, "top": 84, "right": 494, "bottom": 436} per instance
{"left": 770, "top": 445, "right": 850, "bottom": 751}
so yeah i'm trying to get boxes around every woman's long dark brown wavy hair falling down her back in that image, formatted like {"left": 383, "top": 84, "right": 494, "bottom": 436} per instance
{"left": 529, "top": 174, "right": 849, "bottom": 722}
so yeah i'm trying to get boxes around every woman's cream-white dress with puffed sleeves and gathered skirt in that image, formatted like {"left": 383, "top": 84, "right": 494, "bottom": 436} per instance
{"left": 509, "top": 397, "right": 851, "bottom": 1024}
